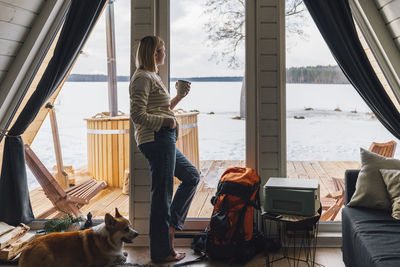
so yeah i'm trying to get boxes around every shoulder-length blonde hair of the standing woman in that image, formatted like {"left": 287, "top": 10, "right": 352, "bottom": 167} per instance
{"left": 136, "top": 36, "right": 164, "bottom": 72}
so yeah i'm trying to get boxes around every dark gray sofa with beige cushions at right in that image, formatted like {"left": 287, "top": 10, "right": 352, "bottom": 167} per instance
{"left": 342, "top": 170, "right": 400, "bottom": 267}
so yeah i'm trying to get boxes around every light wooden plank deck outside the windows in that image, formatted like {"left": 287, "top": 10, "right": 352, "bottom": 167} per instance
{"left": 30, "top": 160, "right": 360, "bottom": 221}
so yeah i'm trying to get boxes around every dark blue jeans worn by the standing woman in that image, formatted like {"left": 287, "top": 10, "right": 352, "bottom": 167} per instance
{"left": 139, "top": 127, "right": 200, "bottom": 260}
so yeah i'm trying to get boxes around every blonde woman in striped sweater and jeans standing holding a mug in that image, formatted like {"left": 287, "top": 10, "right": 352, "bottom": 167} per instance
{"left": 130, "top": 36, "right": 200, "bottom": 261}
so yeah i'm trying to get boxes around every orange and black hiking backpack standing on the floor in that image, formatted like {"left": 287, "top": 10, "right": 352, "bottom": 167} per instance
{"left": 206, "top": 167, "right": 260, "bottom": 263}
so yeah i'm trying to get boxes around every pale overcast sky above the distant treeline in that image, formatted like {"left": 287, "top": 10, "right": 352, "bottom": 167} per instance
{"left": 72, "top": 0, "right": 336, "bottom": 77}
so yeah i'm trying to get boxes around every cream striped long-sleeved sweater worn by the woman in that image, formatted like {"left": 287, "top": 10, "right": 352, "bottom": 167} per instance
{"left": 130, "top": 69, "right": 175, "bottom": 145}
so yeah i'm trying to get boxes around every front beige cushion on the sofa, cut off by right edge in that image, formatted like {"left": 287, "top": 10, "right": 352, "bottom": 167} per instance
{"left": 380, "top": 170, "right": 400, "bottom": 220}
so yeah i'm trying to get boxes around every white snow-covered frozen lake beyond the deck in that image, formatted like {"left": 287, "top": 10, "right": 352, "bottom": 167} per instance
{"left": 28, "top": 82, "right": 399, "bottom": 188}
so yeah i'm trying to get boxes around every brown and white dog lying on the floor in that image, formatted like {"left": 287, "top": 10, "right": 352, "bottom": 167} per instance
{"left": 18, "top": 209, "right": 138, "bottom": 267}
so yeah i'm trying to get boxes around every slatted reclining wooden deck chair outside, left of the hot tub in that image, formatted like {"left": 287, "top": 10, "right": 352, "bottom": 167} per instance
{"left": 25, "top": 145, "right": 107, "bottom": 219}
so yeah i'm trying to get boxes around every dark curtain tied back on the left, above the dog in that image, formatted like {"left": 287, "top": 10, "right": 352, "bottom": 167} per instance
{"left": 0, "top": 0, "right": 107, "bottom": 225}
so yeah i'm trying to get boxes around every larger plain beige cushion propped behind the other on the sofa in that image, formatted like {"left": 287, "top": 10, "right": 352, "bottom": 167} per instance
{"left": 347, "top": 148, "right": 400, "bottom": 211}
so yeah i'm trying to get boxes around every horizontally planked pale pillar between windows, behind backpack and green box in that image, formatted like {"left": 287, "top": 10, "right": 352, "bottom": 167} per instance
{"left": 256, "top": 0, "right": 286, "bottom": 193}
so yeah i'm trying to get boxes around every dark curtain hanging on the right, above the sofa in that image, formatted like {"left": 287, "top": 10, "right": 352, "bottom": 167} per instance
{"left": 304, "top": 0, "right": 400, "bottom": 139}
